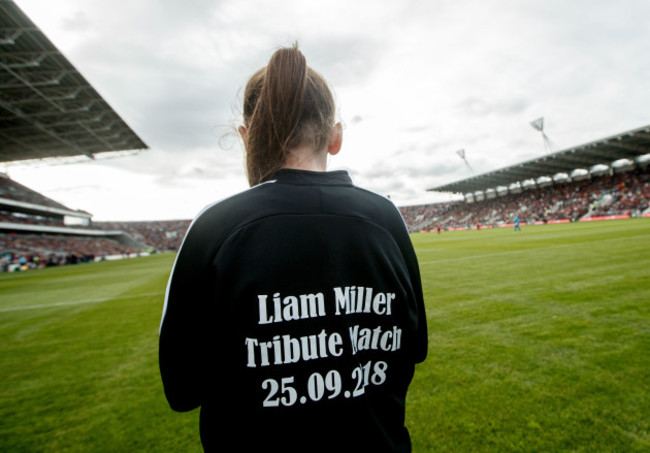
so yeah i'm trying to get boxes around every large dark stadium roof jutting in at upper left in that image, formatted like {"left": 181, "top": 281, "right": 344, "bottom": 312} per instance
{"left": 0, "top": 0, "right": 148, "bottom": 162}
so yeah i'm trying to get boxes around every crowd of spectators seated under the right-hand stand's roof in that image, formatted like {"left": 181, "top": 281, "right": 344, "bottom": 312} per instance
{"left": 400, "top": 166, "right": 650, "bottom": 231}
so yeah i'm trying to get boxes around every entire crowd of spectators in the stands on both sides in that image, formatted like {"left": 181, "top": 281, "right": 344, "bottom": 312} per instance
{"left": 0, "top": 166, "right": 650, "bottom": 270}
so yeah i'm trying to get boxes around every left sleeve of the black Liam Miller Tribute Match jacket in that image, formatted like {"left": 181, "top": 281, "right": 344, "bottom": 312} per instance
{"left": 158, "top": 217, "right": 211, "bottom": 411}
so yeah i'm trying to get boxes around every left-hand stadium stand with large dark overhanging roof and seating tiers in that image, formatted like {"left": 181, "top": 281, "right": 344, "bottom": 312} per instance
{"left": 0, "top": 0, "right": 149, "bottom": 270}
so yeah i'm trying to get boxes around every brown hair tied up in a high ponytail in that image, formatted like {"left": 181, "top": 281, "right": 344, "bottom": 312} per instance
{"left": 244, "top": 45, "right": 335, "bottom": 186}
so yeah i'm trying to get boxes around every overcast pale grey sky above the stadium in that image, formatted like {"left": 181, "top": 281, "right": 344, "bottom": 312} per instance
{"left": 5, "top": 0, "right": 650, "bottom": 220}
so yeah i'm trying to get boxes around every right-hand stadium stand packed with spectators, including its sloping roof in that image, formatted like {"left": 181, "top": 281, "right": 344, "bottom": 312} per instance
{"left": 402, "top": 122, "right": 650, "bottom": 231}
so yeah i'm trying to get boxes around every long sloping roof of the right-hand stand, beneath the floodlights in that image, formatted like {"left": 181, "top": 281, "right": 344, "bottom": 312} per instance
{"left": 427, "top": 125, "right": 650, "bottom": 194}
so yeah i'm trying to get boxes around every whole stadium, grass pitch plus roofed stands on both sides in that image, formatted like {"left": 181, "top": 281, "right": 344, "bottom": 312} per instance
{"left": 0, "top": 2, "right": 650, "bottom": 451}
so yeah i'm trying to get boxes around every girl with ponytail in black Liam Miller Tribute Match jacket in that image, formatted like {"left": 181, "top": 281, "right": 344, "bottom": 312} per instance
{"left": 159, "top": 46, "right": 427, "bottom": 452}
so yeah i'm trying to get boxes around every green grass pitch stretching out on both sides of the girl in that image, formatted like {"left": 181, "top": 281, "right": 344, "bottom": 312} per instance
{"left": 0, "top": 219, "right": 650, "bottom": 452}
